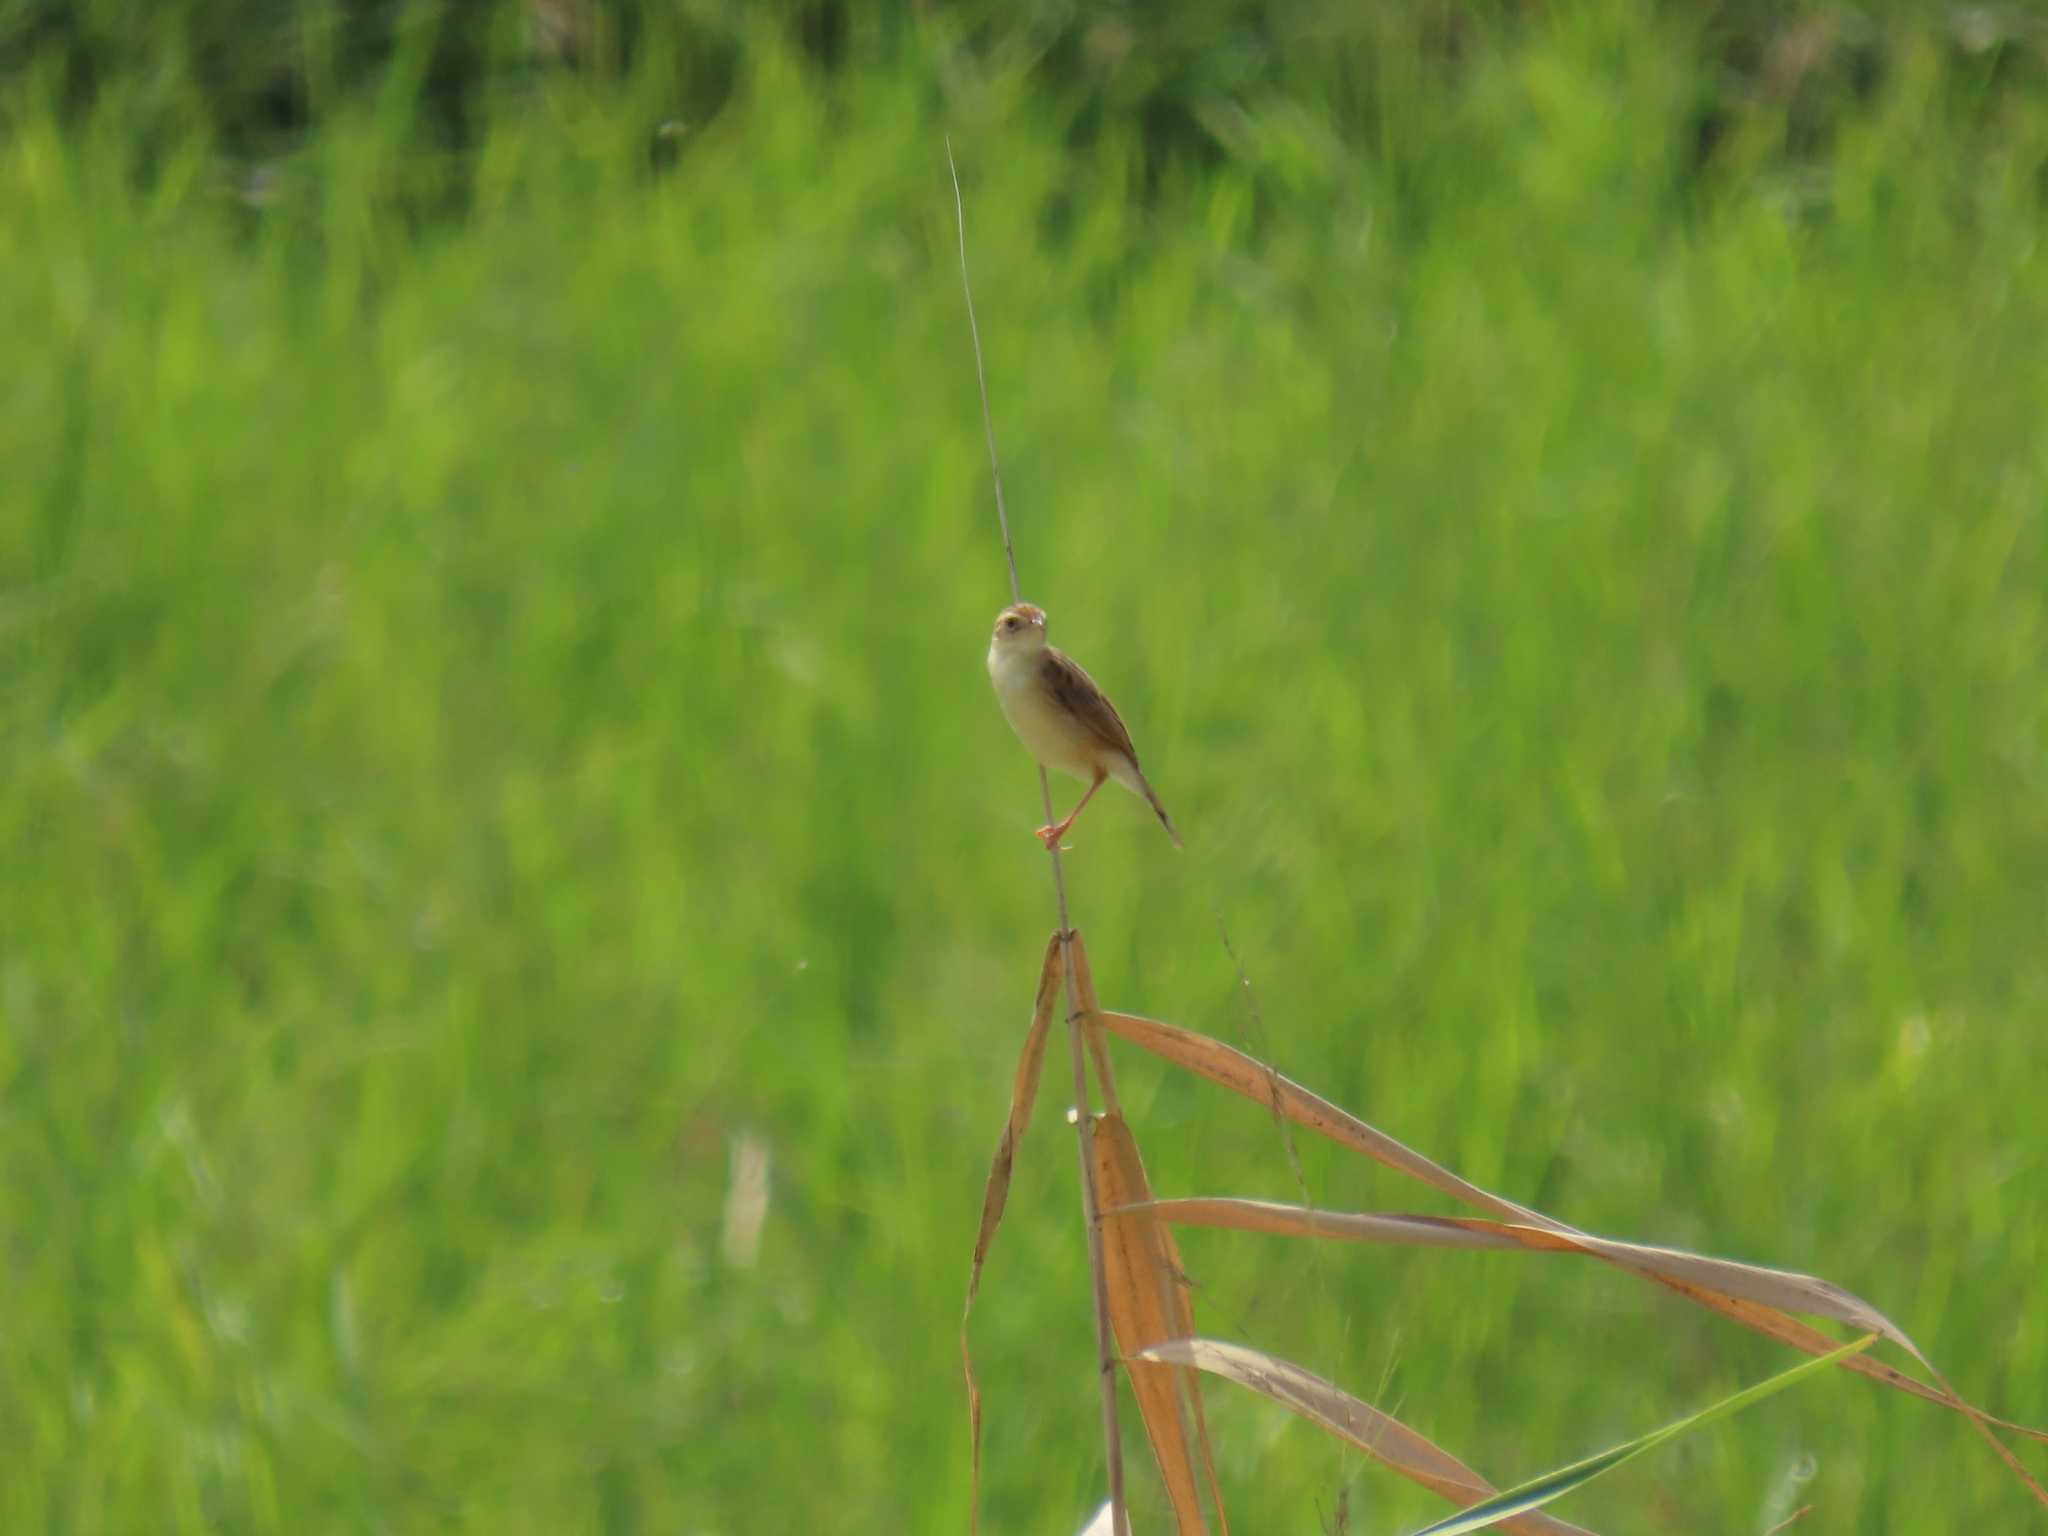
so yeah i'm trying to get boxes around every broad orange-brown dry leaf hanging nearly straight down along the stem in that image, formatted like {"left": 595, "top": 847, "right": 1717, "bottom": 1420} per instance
{"left": 1090, "top": 1114, "right": 1229, "bottom": 1532}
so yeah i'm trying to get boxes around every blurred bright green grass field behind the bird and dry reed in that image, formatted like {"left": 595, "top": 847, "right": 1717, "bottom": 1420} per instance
{"left": 0, "top": 6, "right": 2048, "bottom": 1532}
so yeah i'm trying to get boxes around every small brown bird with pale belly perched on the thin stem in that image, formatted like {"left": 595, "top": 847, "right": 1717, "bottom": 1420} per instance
{"left": 989, "top": 602, "right": 1180, "bottom": 848}
